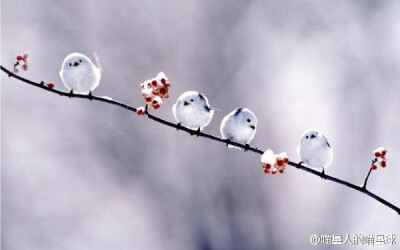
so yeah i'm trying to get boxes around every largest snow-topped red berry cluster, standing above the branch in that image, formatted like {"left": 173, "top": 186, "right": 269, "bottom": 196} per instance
{"left": 140, "top": 72, "right": 171, "bottom": 109}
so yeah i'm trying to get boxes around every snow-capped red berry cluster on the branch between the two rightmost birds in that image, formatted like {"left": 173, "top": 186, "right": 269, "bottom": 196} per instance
{"left": 261, "top": 149, "right": 289, "bottom": 174}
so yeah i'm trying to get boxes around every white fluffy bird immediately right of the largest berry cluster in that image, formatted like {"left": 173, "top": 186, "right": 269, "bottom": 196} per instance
{"left": 172, "top": 91, "right": 214, "bottom": 131}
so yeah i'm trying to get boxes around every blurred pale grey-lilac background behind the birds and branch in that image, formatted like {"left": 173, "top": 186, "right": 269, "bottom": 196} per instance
{"left": 1, "top": 0, "right": 400, "bottom": 249}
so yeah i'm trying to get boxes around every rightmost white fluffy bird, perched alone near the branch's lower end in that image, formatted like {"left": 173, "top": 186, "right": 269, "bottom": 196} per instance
{"left": 297, "top": 129, "right": 333, "bottom": 178}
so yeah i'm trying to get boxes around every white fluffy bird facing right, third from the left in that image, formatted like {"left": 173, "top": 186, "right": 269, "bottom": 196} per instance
{"left": 220, "top": 108, "right": 257, "bottom": 148}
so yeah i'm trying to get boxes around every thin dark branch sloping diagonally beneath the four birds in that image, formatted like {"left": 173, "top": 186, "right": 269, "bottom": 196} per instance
{"left": 0, "top": 65, "right": 400, "bottom": 214}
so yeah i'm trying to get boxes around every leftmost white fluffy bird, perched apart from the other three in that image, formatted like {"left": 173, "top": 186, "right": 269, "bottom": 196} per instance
{"left": 60, "top": 53, "right": 101, "bottom": 96}
